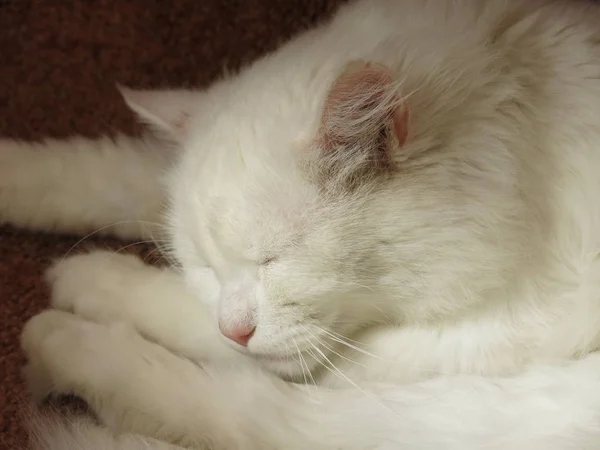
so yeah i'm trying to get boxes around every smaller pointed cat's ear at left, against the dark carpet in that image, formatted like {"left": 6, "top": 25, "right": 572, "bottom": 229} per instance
{"left": 117, "top": 85, "right": 198, "bottom": 140}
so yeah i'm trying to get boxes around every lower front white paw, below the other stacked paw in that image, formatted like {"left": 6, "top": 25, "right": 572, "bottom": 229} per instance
{"left": 21, "top": 310, "right": 137, "bottom": 401}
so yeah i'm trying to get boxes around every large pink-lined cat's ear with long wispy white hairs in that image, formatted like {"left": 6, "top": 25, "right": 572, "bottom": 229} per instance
{"left": 317, "top": 61, "right": 409, "bottom": 185}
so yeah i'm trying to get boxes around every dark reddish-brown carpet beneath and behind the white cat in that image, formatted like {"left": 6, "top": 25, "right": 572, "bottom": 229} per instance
{"left": 0, "top": 0, "right": 342, "bottom": 449}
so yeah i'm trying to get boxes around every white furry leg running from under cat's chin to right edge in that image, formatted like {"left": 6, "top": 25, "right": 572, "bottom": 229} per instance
{"left": 321, "top": 289, "right": 600, "bottom": 387}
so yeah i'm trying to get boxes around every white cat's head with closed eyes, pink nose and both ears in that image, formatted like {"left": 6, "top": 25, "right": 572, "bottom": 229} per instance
{"left": 118, "top": 62, "right": 502, "bottom": 374}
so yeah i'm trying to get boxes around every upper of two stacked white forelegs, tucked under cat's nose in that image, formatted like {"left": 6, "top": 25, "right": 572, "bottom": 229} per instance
{"left": 47, "top": 251, "right": 241, "bottom": 361}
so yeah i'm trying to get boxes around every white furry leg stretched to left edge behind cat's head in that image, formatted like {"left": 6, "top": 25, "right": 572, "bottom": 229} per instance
{"left": 0, "top": 136, "right": 170, "bottom": 238}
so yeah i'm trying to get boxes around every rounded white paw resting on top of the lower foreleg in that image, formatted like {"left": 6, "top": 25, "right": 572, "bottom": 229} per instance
{"left": 46, "top": 251, "right": 157, "bottom": 323}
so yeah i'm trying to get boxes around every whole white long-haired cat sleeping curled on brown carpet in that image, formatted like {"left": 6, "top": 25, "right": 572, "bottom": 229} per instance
{"left": 5, "top": 0, "right": 600, "bottom": 450}
